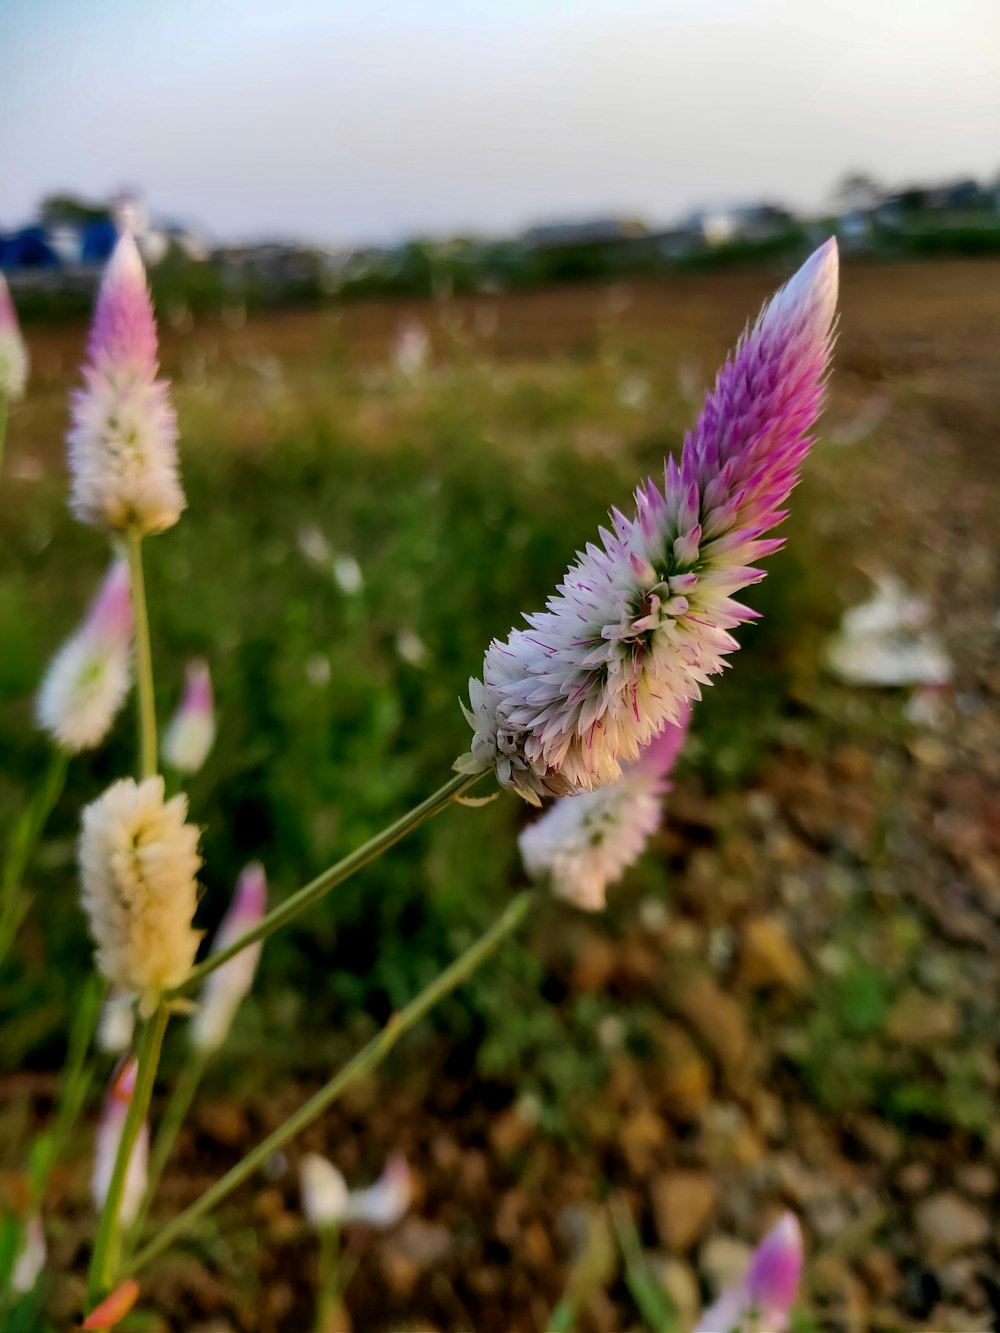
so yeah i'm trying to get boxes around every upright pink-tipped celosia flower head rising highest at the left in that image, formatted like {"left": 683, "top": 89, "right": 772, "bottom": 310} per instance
{"left": 69, "top": 235, "right": 185, "bottom": 536}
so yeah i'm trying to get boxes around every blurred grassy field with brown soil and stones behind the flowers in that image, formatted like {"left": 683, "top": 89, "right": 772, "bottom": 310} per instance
{"left": 0, "top": 254, "right": 1000, "bottom": 1333}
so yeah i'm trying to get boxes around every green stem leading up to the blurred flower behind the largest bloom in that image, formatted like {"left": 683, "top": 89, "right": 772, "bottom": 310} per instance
{"left": 129, "top": 890, "right": 535, "bottom": 1277}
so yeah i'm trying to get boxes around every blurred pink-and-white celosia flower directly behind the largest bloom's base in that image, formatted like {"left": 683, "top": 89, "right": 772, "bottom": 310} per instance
{"left": 517, "top": 704, "right": 691, "bottom": 912}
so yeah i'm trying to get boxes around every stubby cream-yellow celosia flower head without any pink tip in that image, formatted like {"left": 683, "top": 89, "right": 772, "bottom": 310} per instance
{"left": 79, "top": 777, "right": 201, "bottom": 1014}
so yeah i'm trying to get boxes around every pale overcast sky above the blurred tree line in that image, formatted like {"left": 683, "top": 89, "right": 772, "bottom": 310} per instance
{"left": 7, "top": 0, "right": 1000, "bottom": 243}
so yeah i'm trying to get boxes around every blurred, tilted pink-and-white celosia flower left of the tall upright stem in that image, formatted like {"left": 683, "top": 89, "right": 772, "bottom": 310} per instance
{"left": 36, "top": 560, "right": 132, "bottom": 753}
